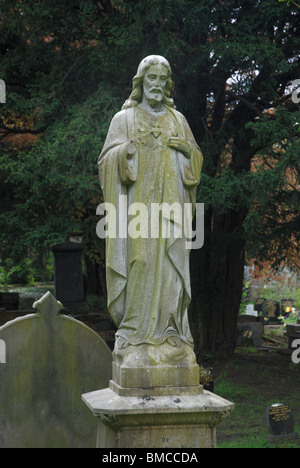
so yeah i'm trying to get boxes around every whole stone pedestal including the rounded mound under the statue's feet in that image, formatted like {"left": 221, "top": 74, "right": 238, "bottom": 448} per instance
{"left": 82, "top": 343, "right": 234, "bottom": 448}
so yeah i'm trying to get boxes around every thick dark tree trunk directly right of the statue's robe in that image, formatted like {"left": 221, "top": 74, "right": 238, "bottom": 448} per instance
{"left": 190, "top": 207, "right": 245, "bottom": 362}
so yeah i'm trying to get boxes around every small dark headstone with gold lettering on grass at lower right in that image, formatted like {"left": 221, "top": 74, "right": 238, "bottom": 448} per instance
{"left": 266, "top": 403, "right": 298, "bottom": 442}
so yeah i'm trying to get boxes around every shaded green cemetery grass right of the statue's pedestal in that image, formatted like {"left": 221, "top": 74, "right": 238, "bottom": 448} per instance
{"left": 213, "top": 348, "right": 300, "bottom": 448}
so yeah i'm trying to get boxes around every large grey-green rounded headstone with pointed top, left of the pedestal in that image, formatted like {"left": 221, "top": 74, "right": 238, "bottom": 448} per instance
{"left": 0, "top": 292, "right": 112, "bottom": 448}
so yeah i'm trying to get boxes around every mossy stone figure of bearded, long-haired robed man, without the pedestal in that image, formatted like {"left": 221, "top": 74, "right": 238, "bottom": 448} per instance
{"left": 98, "top": 56, "right": 203, "bottom": 372}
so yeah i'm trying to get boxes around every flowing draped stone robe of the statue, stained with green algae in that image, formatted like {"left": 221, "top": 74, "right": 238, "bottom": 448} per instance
{"left": 98, "top": 106, "right": 203, "bottom": 354}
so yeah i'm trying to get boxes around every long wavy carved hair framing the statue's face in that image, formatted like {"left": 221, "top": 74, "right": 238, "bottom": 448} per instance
{"left": 122, "top": 55, "right": 175, "bottom": 109}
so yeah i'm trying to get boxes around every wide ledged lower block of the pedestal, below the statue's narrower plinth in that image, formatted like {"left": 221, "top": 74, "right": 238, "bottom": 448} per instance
{"left": 82, "top": 381, "right": 234, "bottom": 448}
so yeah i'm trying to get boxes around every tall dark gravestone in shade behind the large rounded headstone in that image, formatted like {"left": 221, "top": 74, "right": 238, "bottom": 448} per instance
{"left": 52, "top": 241, "right": 85, "bottom": 313}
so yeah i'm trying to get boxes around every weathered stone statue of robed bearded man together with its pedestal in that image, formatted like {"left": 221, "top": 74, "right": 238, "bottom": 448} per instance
{"left": 82, "top": 56, "right": 234, "bottom": 448}
